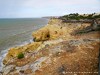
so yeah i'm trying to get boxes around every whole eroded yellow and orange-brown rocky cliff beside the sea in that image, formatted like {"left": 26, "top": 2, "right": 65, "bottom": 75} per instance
{"left": 2, "top": 19, "right": 100, "bottom": 75}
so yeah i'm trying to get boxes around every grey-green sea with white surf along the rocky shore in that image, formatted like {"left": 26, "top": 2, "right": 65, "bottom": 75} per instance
{"left": 0, "top": 18, "right": 49, "bottom": 70}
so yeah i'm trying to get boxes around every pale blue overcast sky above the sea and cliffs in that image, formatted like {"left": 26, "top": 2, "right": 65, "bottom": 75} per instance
{"left": 0, "top": 0, "right": 100, "bottom": 18}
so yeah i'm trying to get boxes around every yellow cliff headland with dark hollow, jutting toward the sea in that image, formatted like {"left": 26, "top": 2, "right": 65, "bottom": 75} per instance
{"left": 32, "top": 19, "right": 91, "bottom": 42}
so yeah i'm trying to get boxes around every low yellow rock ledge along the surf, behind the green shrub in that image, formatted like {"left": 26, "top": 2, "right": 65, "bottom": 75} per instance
{"left": 3, "top": 42, "right": 42, "bottom": 64}
